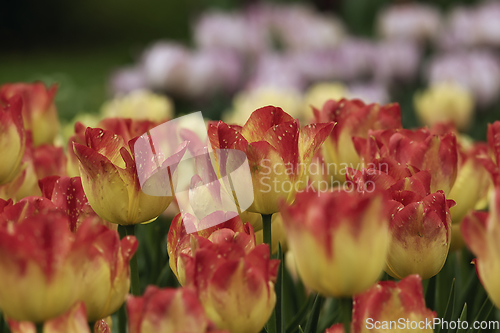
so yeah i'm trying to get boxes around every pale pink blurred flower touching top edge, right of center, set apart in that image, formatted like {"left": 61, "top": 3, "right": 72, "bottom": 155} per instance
{"left": 377, "top": 3, "right": 441, "bottom": 41}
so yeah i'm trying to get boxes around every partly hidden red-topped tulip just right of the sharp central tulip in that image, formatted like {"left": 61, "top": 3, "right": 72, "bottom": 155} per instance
{"left": 314, "top": 99, "right": 401, "bottom": 181}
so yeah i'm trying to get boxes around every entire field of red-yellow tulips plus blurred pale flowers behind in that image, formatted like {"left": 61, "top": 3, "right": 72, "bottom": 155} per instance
{"left": 0, "top": 1, "right": 500, "bottom": 333}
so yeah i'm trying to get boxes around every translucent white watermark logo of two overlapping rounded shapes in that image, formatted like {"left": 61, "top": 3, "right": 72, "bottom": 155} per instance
{"left": 134, "top": 112, "right": 254, "bottom": 233}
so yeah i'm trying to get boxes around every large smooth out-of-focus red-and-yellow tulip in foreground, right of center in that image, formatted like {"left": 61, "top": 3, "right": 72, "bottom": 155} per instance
{"left": 281, "top": 191, "right": 390, "bottom": 297}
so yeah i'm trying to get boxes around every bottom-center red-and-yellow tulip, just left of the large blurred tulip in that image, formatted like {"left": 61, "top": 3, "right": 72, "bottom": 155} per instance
{"left": 181, "top": 233, "right": 279, "bottom": 333}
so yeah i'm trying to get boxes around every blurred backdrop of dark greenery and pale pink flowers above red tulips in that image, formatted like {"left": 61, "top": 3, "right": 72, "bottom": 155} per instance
{"left": 0, "top": 0, "right": 500, "bottom": 139}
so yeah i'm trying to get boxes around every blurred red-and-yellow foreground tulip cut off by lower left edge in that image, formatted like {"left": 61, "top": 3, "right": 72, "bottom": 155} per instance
{"left": 0, "top": 211, "right": 86, "bottom": 323}
